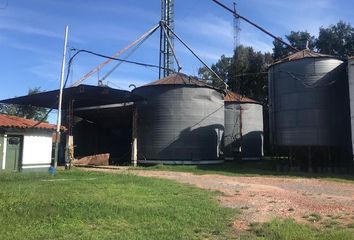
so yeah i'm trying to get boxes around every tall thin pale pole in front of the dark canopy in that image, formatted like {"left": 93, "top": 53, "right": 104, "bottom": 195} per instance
{"left": 52, "top": 26, "right": 69, "bottom": 169}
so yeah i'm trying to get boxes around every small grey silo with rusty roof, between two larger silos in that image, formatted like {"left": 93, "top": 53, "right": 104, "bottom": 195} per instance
{"left": 223, "top": 91, "right": 263, "bottom": 160}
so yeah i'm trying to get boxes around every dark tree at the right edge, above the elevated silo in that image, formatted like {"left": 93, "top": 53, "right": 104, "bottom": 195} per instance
{"left": 316, "top": 21, "right": 354, "bottom": 57}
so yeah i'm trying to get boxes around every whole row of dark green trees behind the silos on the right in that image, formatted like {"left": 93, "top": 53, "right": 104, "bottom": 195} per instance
{"left": 198, "top": 21, "right": 354, "bottom": 105}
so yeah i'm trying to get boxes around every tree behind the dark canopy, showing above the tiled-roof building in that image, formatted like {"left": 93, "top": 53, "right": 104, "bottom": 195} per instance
{"left": 0, "top": 87, "right": 48, "bottom": 121}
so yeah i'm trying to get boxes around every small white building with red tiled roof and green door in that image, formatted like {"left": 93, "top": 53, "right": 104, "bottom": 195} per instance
{"left": 0, "top": 114, "right": 56, "bottom": 172}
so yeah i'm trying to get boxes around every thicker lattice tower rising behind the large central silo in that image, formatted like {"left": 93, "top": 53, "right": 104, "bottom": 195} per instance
{"left": 159, "top": 0, "right": 175, "bottom": 78}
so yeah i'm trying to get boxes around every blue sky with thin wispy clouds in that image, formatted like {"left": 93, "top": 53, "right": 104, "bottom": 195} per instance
{"left": 0, "top": 0, "right": 354, "bottom": 99}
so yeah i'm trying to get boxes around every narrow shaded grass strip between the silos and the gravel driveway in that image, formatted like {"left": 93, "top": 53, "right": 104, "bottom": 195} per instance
{"left": 136, "top": 160, "right": 354, "bottom": 182}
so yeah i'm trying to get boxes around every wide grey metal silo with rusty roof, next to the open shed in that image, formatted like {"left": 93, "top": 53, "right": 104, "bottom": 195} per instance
{"left": 133, "top": 74, "right": 224, "bottom": 164}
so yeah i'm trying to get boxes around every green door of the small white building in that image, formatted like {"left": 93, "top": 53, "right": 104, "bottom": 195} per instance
{"left": 5, "top": 135, "right": 22, "bottom": 171}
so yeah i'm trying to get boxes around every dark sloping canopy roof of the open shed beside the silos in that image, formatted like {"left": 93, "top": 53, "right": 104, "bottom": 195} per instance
{"left": 0, "top": 85, "right": 142, "bottom": 109}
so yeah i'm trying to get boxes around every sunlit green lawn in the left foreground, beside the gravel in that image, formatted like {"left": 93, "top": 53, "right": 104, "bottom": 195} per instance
{"left": 0, "top": 170, "right": 235, "bottom": 240}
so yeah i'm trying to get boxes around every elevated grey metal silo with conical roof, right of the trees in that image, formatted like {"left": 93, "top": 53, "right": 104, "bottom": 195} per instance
{"left": 268, "top": 50, "right": 350, "bottom": 146}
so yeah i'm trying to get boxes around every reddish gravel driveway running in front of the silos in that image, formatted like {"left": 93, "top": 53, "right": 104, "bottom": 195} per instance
{"left": 79, "top": 168, "right": 354, "bottom": 229}
